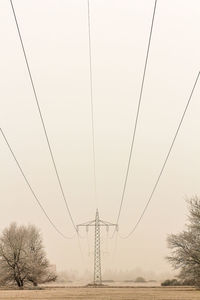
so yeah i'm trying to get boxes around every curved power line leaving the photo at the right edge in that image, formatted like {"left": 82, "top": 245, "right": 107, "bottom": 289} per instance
{"left": 120, "top": 72, "right": 200, "bottom": 239}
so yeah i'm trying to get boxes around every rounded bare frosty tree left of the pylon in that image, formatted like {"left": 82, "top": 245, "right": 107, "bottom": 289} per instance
{"left": 0, "top": 223, "right": 56, "bottom": 288}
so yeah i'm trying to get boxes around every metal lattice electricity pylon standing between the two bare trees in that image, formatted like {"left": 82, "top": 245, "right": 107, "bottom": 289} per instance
{"left": 77, "top": 209, "right": 118, "bottom": 286}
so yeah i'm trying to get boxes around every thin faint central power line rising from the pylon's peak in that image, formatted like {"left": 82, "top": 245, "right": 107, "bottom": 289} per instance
{"left": 87, "top": 0, "right": 98, "bottom": 206}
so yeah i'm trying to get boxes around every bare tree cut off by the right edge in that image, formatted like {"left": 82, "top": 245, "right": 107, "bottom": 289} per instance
{"left": 167, "top": 197, "right": 200, "bottom": 286}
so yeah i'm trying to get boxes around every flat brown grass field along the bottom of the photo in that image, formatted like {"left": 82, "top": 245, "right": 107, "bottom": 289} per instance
{"left": 0, "top": 287, "right": 200, "bottom": 300}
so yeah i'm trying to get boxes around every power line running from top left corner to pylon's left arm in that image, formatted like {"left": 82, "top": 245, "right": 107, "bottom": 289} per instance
{"left": 10, "top": 0, "right": 76, "bottom": 231}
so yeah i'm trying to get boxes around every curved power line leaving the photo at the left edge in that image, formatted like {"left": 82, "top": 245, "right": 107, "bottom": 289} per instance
{"left": 0, "top": 128, "right": 73, "bottom": 239}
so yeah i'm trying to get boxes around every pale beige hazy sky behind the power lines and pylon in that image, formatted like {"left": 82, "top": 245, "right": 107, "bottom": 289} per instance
{"left": 0, "top": 0, "right": 200, "bottom": 272}
